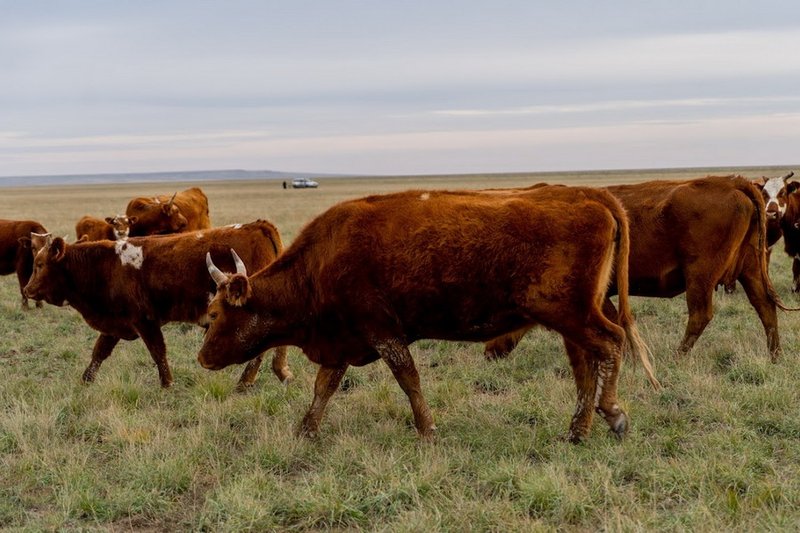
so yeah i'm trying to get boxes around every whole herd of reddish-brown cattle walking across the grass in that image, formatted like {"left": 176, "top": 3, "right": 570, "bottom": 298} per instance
{"left": 0, "top": 174, "right": 800, "bottom": 442}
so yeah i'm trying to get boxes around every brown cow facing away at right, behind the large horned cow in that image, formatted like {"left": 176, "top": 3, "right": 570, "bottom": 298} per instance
{"left": 485, "top": 176, "right": 790, "bottom": 362}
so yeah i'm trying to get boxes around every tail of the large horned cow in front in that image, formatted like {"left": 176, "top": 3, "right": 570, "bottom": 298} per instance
{"left": 612, "top": 199, "right": 661, "bottom": 390}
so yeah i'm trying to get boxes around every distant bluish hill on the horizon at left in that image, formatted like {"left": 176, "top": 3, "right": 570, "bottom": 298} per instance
{"left": 0, "top": 170, "right": 335, "bottom": 187}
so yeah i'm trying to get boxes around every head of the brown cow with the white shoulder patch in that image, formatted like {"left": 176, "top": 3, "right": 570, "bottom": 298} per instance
{"left": 24, "top": 233, "right": 67, "bottom": 306}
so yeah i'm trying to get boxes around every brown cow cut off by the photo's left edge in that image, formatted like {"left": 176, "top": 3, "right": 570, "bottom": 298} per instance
{"left": 0, "top": 220, "right": 47, "bottom": 309}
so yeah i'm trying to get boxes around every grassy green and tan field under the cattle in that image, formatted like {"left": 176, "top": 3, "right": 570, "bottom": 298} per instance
{"left": 0, "top": 169, "right": 800, "bottom": 531}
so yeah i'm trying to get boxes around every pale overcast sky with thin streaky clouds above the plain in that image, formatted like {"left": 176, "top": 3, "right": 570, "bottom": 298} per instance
{"left": 0, "top": 0, "right": 800, "bottom": 179}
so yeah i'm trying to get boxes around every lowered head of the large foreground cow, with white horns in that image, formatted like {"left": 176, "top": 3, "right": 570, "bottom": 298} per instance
{"left": 197, "top": 250, "right": 264, "bottom": 370}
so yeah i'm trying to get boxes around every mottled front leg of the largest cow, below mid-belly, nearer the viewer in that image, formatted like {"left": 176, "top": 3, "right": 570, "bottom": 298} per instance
{"left": 375, "top": 339, "right": 436, "bottom": 439}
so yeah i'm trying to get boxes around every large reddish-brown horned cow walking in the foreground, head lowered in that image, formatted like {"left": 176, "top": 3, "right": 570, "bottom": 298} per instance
{"left": 198, "top": 187, "right": 658, "bottom": 442}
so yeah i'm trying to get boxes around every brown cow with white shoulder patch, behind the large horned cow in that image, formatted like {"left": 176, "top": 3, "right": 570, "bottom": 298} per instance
{"left": 25, "top": 220, "right": 292, "bottom": 388}
